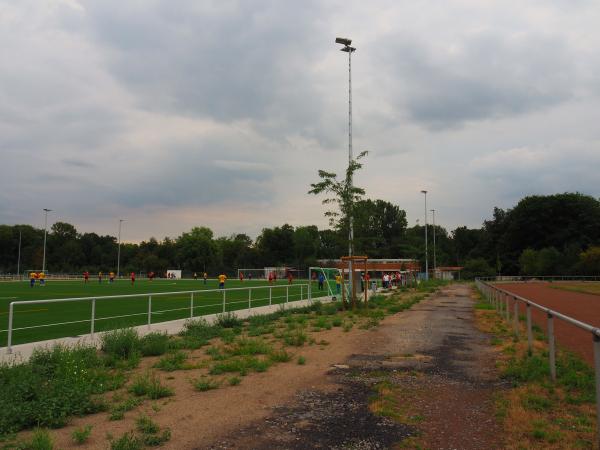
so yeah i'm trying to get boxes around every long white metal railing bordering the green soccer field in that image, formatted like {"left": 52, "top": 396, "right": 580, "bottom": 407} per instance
{"left": 0, "top": 283, "right": 312, "bottom": 354}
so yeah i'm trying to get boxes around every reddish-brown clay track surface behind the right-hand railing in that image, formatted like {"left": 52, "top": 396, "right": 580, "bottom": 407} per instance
{"left": 497, "top": 282, "right": 600, "bottom": 365}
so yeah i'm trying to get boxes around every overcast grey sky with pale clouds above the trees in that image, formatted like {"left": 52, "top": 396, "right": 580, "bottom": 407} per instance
{"left": 0, "top": 0, "right": 600, "bottom": 241}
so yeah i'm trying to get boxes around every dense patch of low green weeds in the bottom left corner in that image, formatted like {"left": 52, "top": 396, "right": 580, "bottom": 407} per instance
{"left": 0, "top": 345, "right": 115, "bottom": 435}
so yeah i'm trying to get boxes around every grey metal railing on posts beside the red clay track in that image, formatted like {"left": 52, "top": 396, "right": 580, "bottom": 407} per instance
{"left": 475, "top": 277, "right": 600, "bottom": 445}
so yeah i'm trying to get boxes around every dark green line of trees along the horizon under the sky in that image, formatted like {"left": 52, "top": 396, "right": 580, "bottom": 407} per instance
{"left": 0, "top": 193, "right": 600, "bottom": 278}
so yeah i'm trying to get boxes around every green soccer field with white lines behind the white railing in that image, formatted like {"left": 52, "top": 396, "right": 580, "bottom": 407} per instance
{"left": 0, "top": 280, "right": 317, "bottom": 347}
